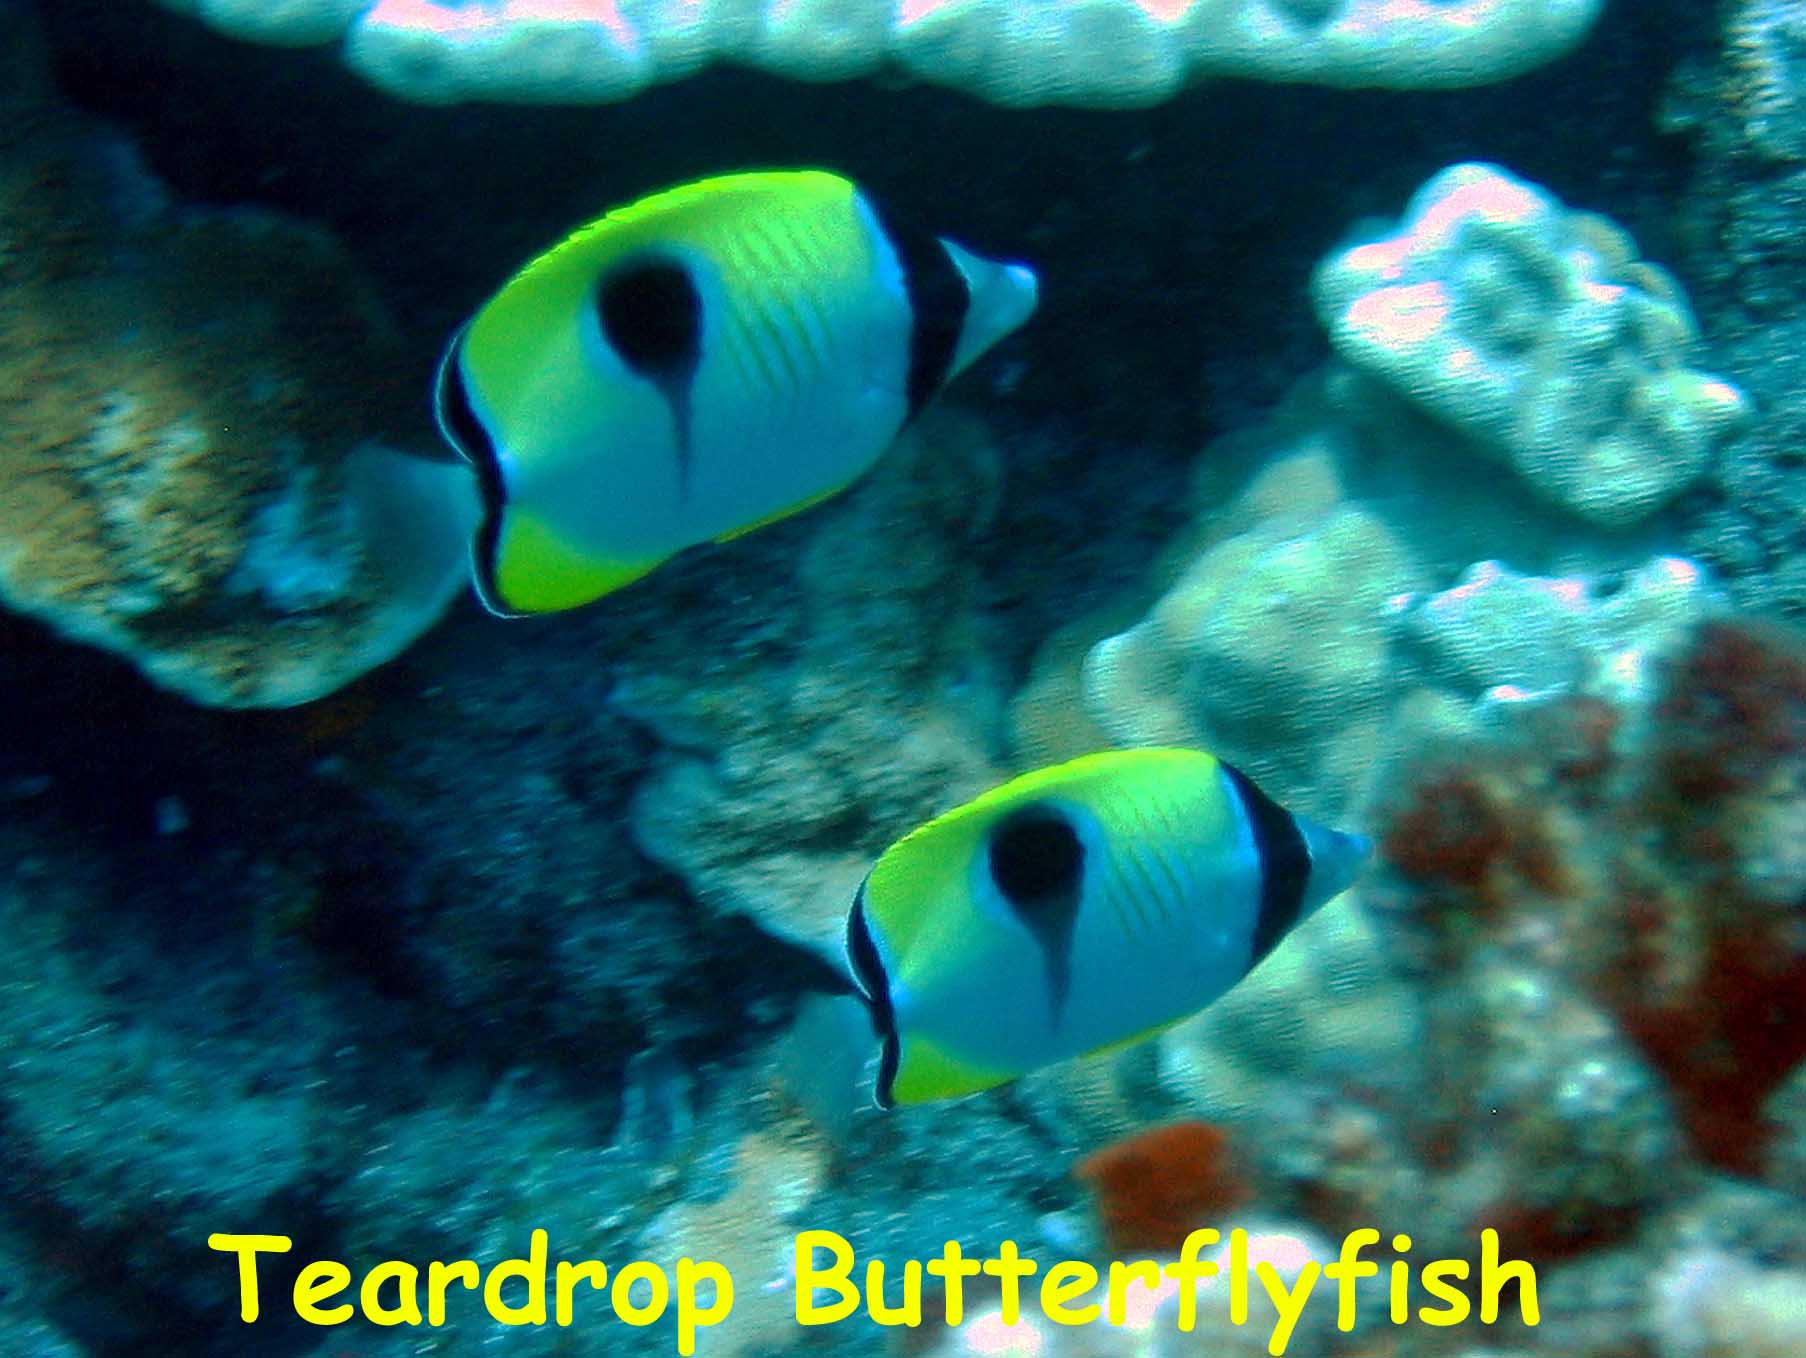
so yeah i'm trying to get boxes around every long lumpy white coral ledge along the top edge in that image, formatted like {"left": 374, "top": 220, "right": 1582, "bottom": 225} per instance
{"left": 151, "top": 0, "right": 1600, "bottom": 107}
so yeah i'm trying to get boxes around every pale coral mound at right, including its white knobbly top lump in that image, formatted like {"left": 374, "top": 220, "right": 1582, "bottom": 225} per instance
{"left": 1013, "top": 164, "right": 1746, "bottom": 818}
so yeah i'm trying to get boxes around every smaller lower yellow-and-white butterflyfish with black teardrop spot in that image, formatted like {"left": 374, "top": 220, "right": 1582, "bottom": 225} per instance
{"left": 827, "top": 749, "right": 1369, "bottom": 1107}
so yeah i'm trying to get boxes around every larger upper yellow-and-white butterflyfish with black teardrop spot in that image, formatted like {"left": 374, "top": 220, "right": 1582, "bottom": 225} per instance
{"left": 435, "top": 170, "right": 1035, "bottom": 616}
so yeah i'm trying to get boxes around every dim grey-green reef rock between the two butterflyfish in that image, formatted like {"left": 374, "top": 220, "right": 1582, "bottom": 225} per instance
{"left": 610, "top": 410, "right": 1004, "bottom": 943}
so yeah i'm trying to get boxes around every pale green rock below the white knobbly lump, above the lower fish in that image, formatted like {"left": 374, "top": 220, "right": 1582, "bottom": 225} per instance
{"left": 1054, "top": 346, "right": 1727, "bottom": 818}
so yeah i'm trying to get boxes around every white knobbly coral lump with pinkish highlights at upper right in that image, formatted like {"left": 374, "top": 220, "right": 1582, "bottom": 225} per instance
{"left": 1313, "top": 164, "right": 1748, "bottom": 526}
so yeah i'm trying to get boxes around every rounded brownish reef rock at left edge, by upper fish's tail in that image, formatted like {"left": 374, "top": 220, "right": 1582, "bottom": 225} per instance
{"left": 0, "top": 9, "right": 475, "bottom": 706}
